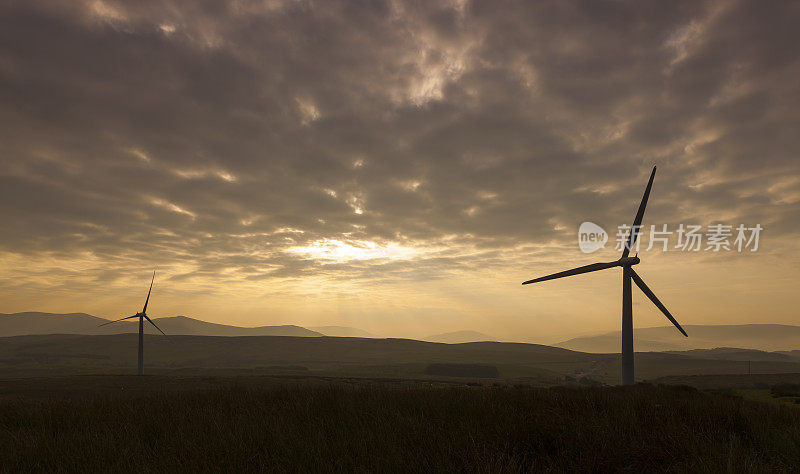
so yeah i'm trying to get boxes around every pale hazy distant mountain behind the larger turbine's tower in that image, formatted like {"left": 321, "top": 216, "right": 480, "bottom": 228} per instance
{"left": 554, "top": 324, "right": 800, "bottom": 353}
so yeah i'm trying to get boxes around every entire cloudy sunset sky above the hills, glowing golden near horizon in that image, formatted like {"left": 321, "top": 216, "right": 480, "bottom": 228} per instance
{"left": 0, "top": 0, "right": 800, "bottom": 343}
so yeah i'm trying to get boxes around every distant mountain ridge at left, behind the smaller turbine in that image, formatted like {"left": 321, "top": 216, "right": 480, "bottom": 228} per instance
{"left": 0, "top": 313, "right": 322, "bottom": 337}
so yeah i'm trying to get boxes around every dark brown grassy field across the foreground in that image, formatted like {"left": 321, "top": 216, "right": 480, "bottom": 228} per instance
{"left": 0, "top": 376, "right": 800, "bottom": 472}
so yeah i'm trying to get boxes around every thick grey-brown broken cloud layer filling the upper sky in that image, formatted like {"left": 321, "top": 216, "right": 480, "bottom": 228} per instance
{"left": 0, "top": 0, "right": 800, "bottom": 288}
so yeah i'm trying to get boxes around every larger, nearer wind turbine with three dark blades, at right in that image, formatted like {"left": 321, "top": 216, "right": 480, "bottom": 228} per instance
{"left": 523, "top": 166, "right": 689, "bottom": 385}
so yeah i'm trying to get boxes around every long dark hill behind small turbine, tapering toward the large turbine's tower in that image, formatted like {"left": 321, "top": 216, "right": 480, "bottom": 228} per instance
{"left": 0, "top": 334, "right": 588, "bottom": 375}
